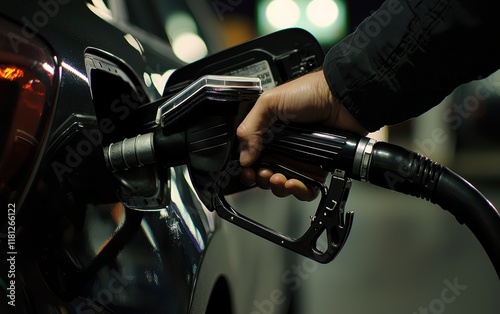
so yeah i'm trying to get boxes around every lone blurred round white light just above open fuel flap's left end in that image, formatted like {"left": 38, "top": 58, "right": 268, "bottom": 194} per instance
{"left": 172, "top": 33, "right": 208, "bottom": 62}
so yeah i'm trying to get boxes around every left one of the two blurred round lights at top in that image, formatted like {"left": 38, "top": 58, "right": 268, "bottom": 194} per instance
{"left": 266, "top": 0, "right": 300, "bottom": 28}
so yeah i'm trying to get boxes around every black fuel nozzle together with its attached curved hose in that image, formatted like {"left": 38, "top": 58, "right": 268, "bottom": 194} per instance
{"left": 104, "top": 76, "right": 500, "bottom": 274}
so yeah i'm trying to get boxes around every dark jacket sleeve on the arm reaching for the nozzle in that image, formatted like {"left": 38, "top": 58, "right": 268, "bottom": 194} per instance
{"left": 323, "top": 0, "right": 500, "bottom": 131}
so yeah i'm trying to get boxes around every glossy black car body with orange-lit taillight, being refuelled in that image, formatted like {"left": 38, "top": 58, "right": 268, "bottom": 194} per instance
{"left": 0, "top": 0, "right": 294, "bottom": 313}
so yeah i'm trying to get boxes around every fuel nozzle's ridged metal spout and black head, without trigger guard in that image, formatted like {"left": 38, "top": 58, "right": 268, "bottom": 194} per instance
{"left": 104, "top": 75, "right": 262, "bottom": 171}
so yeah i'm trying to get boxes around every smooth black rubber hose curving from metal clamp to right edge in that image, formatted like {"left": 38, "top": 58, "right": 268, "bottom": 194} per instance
{"left": 367, "top": 142, "right": 500, "bottom": 278}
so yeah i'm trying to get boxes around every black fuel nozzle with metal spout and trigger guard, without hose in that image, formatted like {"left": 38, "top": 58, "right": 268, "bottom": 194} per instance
{"left": 104, "top": 76, "right": 357, "bottom": 263}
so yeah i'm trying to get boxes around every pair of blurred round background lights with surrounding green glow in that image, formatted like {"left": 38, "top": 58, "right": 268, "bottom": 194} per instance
{"left": 256, "top": 0, "right": 348, "bottom": 46}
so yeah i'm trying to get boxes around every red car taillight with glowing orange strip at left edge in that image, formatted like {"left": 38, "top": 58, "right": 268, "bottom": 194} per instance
{"left": 0, "top": 18, "right": 56, "bottom": 204}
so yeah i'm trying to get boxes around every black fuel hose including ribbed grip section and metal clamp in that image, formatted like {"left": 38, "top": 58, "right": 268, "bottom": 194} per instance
{"left": 265, "top": 124, "right": 500, "bottom": 278}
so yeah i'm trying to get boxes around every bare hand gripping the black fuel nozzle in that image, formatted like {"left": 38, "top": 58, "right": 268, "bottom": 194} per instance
{"left": 237, "top": 71, "right": 368, "bottom": 200}
